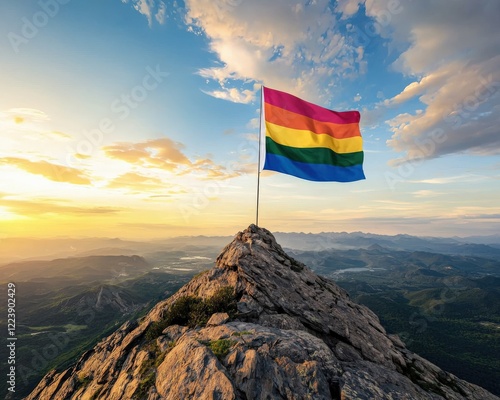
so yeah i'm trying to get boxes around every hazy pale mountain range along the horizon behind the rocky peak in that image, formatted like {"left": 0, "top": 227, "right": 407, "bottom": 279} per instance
{"left": 0, "top": 232, "right": 500, "bottom": 265}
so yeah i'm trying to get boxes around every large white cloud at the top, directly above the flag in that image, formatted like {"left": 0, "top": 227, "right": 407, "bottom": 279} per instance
{"left": 185, "top": 0, "right": 366, "bottom": 103}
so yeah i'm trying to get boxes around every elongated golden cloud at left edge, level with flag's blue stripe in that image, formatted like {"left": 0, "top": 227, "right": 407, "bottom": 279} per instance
{"left": 0, "top": 157, "right": 92, "bottom": 185}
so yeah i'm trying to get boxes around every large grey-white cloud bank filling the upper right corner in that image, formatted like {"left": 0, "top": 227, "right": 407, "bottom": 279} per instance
{"left": 365, "top": 0, "right": 500, "bottom": 162}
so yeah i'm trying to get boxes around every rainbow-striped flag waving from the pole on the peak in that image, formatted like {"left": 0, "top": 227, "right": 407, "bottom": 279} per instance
{"left": 259, "top": 87, "right": 365, "bottom": 182}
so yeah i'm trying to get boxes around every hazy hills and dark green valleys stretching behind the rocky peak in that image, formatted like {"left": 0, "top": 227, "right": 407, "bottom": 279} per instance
{"left": 0, "top": 228, "right": 500, "bottom": 394}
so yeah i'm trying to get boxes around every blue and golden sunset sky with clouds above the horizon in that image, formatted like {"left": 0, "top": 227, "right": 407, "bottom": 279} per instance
{"left": 0, "top": 0, "right": 500, "bottom": 239}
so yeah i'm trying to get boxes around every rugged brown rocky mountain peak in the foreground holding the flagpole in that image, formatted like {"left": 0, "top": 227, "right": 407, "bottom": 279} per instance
{"left": 27, "top": 225, "right": 498, "bottom": 400}
